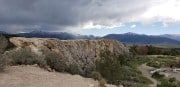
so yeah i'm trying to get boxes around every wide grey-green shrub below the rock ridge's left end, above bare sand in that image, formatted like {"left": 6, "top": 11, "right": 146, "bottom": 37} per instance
{"left": 7, "top": 48, "right": 47, "bottom": 68}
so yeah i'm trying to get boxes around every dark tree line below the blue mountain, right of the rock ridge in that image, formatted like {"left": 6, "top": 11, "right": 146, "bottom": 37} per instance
{"left": 129, "top": 45, "right": 180, "bottom": 56}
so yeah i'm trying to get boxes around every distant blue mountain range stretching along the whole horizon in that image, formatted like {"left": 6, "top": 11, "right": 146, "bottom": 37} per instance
{"left": 0, "top": 31, "right": 180, "bottom": 45}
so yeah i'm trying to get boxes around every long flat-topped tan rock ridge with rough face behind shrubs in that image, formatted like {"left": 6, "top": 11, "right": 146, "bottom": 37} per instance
{"left": 10, "top": 37, "right": 128, "bottom": 74}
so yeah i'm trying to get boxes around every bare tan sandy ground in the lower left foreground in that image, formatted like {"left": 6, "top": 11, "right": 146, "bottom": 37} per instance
{"left": 0, "top": 66, "right": 115, "bottom": 87}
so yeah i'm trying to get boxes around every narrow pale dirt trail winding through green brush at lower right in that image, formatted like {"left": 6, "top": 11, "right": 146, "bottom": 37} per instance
{"left": 138, "top": 64, "right": 157, "bottom": 87}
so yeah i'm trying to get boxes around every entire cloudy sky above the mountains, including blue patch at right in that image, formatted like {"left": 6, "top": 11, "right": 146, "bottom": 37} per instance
{"left": 0, "top": 0, "right": 180, "bottom": 36}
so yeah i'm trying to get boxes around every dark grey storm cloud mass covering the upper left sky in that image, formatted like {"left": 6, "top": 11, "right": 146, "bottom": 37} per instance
{"left": 0, "top": 0, "right": 151, "bottom": 32}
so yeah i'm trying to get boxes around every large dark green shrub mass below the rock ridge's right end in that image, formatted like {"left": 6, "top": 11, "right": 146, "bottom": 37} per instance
{"left": 96, "top": 51, "right": 152, "bottom": 87}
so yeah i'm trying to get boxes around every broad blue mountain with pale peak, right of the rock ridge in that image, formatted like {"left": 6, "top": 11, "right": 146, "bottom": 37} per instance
{"left": 103, "top": 33, "right": 180, "bottom": 44}
